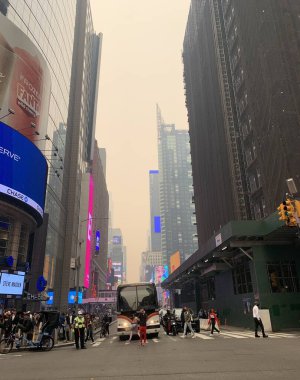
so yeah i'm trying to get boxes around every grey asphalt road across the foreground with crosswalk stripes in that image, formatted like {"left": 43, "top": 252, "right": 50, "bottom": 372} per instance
{"left": 0, "top": 324, "right": 300, "bottom": 380}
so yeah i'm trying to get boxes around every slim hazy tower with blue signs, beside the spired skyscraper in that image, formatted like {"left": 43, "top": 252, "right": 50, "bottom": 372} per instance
{"left": 149, "top": 170, "right": 161, "bottom": 251}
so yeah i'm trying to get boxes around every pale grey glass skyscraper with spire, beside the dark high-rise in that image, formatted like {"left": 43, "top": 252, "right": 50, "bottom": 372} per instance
{"left": 157, "top": 106, "right": 197, "bottom": 266}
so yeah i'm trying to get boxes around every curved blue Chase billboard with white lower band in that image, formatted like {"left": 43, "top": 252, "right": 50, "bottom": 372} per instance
{"left": 0, "top": 121, "right": 48, "bottom": 217}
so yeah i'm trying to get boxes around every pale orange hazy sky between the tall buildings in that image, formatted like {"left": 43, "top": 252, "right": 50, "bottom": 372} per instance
{"left": 91, "top": 0, "right": 190, "bottom": 282}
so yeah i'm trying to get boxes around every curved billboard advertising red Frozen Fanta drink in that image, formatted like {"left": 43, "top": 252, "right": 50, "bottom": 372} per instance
{"left": 0, "top": 13, "right": 51, "bottom": 141}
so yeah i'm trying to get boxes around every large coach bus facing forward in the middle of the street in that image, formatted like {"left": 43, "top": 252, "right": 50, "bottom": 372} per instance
{"left": 117, "top": 282, "right": 160, "bottom": 340}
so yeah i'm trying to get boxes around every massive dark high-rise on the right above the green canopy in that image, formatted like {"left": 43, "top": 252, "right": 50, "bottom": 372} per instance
{"left": 183, "top": 0, "right": 300, "bottom": 243}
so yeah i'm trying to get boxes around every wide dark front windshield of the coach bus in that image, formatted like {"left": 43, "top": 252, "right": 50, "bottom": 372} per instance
{"left": 118, "top": 284, "right": 158, "bottom": 312}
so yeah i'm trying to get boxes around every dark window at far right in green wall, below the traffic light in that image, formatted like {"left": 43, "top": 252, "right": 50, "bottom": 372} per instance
{"left": 267, "top": 261, "right": 299, "bottom": 293}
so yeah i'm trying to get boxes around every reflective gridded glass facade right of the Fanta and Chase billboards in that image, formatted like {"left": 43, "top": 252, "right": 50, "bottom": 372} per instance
{"left": 2, "top": 0, "right": 76, "bottom": 288}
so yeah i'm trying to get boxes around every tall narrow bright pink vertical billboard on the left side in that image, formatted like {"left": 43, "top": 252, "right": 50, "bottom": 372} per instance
{"left": 83, "top": 175, "right": 94, "bottom": 288}
